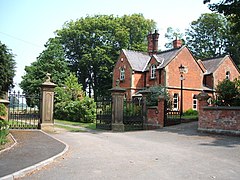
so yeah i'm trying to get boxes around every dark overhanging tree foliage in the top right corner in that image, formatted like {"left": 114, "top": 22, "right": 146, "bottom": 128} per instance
{"left": 203, "top": 0, "right": 240, "bottom": 67}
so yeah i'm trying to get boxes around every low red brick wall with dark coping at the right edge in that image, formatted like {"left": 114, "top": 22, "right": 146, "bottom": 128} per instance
{"left": 198, "top": 106, "right": 240, "bottom": 135}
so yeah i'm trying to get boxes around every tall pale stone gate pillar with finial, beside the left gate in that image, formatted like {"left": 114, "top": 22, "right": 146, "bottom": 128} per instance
{"left": 40, "top": 73, "right": 56, "bottom": 131}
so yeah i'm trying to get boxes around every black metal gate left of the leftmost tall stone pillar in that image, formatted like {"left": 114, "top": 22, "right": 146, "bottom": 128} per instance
{"left": 8, "top": 91, "right": 40, "bottom": 129}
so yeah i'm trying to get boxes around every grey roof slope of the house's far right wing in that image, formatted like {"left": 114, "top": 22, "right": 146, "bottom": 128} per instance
{"left": 202, "top": 56, "right": 225, "bottom": 74}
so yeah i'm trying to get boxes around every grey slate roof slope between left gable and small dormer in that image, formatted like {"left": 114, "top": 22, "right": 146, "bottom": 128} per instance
{"left": 123, "top": 49, "right": 150, "bottom": 71}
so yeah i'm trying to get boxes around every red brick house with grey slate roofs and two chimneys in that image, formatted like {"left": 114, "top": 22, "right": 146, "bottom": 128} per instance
{"left": 113, "top": 31, "right": 240, "bottom": 111}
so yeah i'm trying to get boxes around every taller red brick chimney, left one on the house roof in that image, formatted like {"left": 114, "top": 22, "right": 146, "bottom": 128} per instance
{"left": 147, "top": 30, "right": 159, "bottom": 55}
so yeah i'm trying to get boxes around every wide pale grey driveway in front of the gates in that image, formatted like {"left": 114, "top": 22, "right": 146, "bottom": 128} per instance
{"left": 19, "top": 122, "right": 240, "bottom": 180}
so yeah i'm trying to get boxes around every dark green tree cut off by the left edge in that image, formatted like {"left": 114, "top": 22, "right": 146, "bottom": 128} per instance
{"left": 0, "top": 41, "right": 16, "bottom": 97}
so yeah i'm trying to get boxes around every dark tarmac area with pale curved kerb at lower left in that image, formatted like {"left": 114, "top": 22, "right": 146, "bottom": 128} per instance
{"left": 0, "top": 130, "right": 66, "bottom": 179}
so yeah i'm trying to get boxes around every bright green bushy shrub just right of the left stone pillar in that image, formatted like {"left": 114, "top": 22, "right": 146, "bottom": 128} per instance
{"left": 54, "top": 73, "right": 96, "bottom": 122}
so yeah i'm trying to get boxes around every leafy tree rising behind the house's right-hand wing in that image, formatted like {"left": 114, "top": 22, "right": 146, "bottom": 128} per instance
{"left": 186, "top": 13, "right": 230, "bottom": 58}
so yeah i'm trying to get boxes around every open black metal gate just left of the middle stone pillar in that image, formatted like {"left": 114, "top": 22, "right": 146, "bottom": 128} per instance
{"left": 96, "top": 97, "right": 112, "bottom": 130}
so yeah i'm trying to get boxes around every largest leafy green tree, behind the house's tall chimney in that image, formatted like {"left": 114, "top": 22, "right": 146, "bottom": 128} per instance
{"left": 56, "top": 14, "right": 155, "bottom": 98}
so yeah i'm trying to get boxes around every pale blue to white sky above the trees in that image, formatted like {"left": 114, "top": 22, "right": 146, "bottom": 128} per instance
{"left": 0, "top": 0, "right": 214, "bottom": 89}
